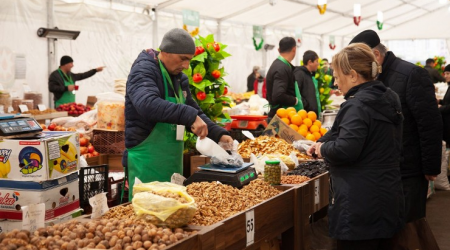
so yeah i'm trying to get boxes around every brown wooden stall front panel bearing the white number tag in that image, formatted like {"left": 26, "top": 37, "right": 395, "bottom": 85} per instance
{"left": 200, "top": 186, "right": 294, "bottom": 250}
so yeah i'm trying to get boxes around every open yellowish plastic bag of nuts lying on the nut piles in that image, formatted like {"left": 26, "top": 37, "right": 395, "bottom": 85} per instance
{"left": 132, "top": 181, "right": 197, "bottom": 228}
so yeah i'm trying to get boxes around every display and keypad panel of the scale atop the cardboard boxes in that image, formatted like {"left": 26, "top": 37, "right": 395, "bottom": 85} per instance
{"left": 0, "top": 117, "right": 42, "bottom": 136}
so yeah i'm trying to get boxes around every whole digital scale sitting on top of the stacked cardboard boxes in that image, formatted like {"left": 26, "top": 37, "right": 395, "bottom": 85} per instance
{"left": 0, "top": 115, "right": 42, "bottom": 139}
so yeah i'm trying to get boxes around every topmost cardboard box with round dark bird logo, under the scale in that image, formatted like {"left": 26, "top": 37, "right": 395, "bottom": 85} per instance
{"left": 0, "top": 132, "right": 80, "bottom": 181}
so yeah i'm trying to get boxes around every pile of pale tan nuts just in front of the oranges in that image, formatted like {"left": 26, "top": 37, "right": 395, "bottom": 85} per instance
{"left": 238, "top": 136, "right": 312, "bottom": 160}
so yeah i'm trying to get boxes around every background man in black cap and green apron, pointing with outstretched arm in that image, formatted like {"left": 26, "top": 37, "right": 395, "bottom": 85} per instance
{"left": 48, "top": 56, "right": 103, "bottom": 107}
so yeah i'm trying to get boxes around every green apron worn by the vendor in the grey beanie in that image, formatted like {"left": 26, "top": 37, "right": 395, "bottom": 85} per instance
{"left": 127, "top": 58, "right": 185, "bottom": 201}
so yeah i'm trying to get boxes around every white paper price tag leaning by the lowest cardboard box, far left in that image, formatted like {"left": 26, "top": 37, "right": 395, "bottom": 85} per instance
{"left": 22, "top": 203, "right": 45, "bottom": 232}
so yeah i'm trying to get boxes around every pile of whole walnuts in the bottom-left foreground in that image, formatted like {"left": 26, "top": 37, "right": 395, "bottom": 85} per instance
{"left": 0, "top": 216, "right": 196, "bottom": 250}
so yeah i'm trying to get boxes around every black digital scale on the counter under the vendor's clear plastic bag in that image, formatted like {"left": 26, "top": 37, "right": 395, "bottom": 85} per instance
{"left": 183, "top": 163, "right": 258, "bottom": 188}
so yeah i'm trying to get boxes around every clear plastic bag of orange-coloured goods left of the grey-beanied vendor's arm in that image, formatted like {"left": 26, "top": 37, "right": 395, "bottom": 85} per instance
{"left": 95, "top": 92, "right": 125, "bottom": 131}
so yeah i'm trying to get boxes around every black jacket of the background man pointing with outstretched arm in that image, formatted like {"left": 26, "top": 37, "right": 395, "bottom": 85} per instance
{"left": 48, "top": 69, "right": 97, "bottom": 102}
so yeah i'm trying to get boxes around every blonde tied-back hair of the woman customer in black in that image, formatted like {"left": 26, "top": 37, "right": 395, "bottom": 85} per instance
{"left": 331, "top": 43, "right": 381, "bottom": 81}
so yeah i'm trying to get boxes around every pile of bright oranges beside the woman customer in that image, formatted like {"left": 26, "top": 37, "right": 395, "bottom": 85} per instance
{"left": 277, "top": 107, "right": 328, "bottom": 141}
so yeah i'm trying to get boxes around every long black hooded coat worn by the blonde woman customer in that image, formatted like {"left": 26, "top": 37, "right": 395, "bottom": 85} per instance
{"left": 319, "top": 81, "right": 404, "bottom": 240}
